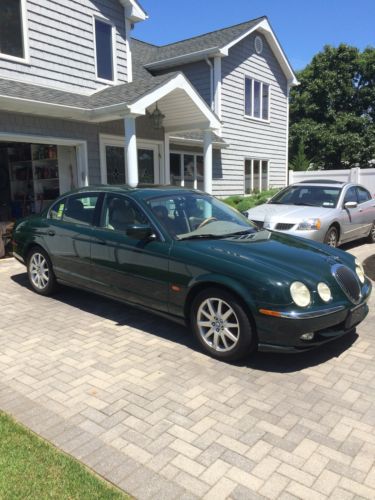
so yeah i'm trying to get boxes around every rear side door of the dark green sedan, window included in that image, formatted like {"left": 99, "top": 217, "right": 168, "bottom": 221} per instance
{"left": 44, "top": 193, "right": 99, "bottom": 288}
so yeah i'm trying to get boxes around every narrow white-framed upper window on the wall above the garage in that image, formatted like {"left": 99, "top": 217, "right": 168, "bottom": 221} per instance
{"left": 95, "top": 19, "right": 114, "bottom": 81}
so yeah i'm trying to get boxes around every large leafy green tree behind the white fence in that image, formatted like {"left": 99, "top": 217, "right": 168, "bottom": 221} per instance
{"left": 289, "top": 44, "right": 375, "bottom": 169}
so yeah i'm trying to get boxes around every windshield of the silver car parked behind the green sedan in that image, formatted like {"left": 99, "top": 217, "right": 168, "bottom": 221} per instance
{"left": 268, "top": 185, "right": 341, "bottom": 208}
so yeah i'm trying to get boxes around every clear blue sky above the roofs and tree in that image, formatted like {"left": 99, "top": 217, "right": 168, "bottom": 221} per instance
{"left": 133, "top": 0, "right": 375, "bottom": 70}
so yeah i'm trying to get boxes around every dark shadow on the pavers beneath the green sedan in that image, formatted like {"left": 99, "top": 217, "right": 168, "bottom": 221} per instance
{"left": 11, "top": 273, "right": 358, "bottom": 373}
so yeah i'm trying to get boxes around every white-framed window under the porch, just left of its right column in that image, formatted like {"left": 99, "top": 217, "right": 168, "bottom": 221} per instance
{"left": 170, "top": 152, "right": 203, "bottom": 189}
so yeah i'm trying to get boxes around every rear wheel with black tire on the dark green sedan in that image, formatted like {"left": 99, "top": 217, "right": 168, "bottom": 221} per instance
{"left": 27, "top": 247, "right": 57, "bottom": 295}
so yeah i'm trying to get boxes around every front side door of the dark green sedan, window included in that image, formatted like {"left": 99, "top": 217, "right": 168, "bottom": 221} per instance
{"left": 91, "top": 194, "right": 170, "bottom": 311}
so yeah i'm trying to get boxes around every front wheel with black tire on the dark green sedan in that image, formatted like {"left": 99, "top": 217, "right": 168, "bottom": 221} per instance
{"left": 190, "top": 288, "right": 257, "bottom": 361}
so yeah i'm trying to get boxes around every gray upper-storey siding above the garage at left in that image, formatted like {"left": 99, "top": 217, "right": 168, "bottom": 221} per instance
{"left": 0, "top": 0, "right": 127, "bottom": 92}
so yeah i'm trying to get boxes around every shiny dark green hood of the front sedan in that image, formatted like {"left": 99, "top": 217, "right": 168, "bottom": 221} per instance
{"left": 183, "top": 230, "right": 354, "bottom": 282}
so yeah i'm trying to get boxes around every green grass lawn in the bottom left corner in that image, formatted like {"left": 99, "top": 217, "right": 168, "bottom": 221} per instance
{"left": 0, "top": 412, "right": 129, "bottom": 500}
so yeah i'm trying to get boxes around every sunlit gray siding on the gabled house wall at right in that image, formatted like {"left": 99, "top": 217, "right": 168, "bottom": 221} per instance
{"left": 213, "top": 33, "right": 287, "bottom": 196}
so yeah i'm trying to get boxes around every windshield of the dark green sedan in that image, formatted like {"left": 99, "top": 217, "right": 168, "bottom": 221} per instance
{"left": 146, "top": 191, "right": 258, "bottom": 240}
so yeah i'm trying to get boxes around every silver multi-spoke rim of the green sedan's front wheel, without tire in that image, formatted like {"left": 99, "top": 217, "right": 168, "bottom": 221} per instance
{"left": 197, "top": 297, "right": 240, "bottom": 352}
